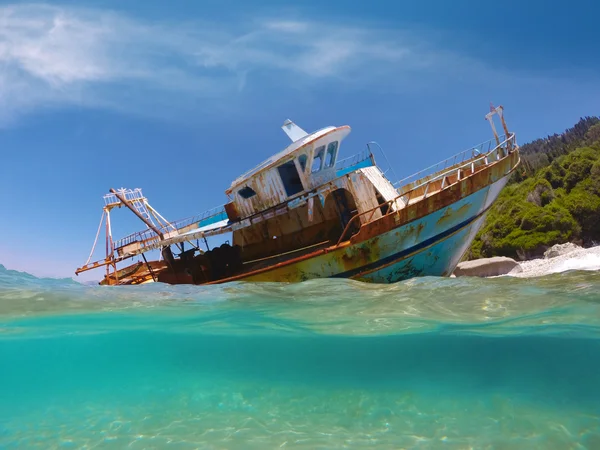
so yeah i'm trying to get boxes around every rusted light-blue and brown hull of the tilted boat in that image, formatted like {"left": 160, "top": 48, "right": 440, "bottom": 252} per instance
{"left": 219, "top": 152, "right": 519, "bottom": 283}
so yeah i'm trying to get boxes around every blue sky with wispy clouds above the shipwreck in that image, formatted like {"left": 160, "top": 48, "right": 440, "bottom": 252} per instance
{"left": 0, "top": 0, "right": 600, "bottom": 280}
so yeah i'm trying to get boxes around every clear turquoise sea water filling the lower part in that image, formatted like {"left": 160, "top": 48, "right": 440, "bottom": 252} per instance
{"left": 0, "top": 266, "right": 600, "bottom": 450}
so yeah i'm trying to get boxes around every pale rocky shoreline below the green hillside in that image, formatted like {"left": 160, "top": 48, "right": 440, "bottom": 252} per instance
{"left": 452, "top": 242, "right": 600, "bottom": 278}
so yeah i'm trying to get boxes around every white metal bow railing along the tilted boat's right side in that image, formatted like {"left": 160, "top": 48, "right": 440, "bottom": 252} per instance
{"left": 336, "top": 133, "right": 516, "bottom": 246}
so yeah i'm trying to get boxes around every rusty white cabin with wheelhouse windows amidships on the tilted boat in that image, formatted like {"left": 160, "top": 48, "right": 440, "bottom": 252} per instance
{"left": 220, "top": 120, "right": 408, "bottom": 268}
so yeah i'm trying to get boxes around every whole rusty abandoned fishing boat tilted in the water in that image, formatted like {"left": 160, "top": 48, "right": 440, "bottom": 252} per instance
{"left": 76, "top": 107, "right": 519, "bottom": 285}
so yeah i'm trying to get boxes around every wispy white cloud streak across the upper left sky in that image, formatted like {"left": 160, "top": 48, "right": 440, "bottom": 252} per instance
{"left": 0, "top": 4, "right": 468, "bottom": 122}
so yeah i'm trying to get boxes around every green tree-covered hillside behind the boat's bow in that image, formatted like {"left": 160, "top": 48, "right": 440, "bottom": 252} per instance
{"left": 466, "top": 117, "right": 600, "bottom": 259}
